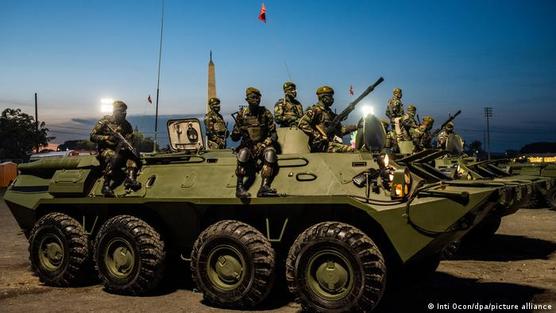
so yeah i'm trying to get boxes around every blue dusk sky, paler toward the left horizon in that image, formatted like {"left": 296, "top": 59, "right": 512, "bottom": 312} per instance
{"left": 0, "top": 0, "right": 556, "bottom": 151}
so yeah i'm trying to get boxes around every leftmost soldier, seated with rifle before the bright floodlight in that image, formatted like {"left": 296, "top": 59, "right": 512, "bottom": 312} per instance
{"left": 91, "top": 100, "right": 141, "bottom": 197}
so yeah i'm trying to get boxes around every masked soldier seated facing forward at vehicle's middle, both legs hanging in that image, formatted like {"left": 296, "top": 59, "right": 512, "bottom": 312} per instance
{"left": 231, "top": 87, "right": 278, "bottom": 198}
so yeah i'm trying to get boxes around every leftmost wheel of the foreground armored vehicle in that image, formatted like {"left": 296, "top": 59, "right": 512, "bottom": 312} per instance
{"left": 29, "top": 212, "right": 89, "bottom": 287}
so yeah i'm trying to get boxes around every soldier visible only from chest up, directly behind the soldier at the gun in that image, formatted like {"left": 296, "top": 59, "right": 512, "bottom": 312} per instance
{"left": 274, "top": 81, "right": 303, "bottom": 127}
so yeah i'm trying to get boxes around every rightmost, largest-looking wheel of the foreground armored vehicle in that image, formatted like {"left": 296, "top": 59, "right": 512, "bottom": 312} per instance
{"left": 286, "top": 222, "right": 386, "bottom": 312}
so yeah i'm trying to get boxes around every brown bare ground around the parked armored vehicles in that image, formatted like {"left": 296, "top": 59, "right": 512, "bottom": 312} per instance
{"left": 0, "top": 186, "right": 556, "bottom": 312}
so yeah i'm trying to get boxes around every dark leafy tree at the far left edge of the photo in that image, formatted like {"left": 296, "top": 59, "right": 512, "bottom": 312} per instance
{"left": 0, "top": 108, "right": 53, "bottom": 159}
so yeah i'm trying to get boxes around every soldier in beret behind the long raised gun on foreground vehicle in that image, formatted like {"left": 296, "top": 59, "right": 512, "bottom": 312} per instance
{"left": 299, "top": 86, "right": 357, "bottom": 152}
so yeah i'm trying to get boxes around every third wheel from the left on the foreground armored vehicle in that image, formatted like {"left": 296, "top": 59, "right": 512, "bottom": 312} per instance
{"left": 191, "top": 220, "right": 275, "bottom": 307}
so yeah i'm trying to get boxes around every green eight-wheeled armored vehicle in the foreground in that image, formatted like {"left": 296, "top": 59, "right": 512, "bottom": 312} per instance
{"left": 4, "top": 81, "right": 519, "bottom": 312}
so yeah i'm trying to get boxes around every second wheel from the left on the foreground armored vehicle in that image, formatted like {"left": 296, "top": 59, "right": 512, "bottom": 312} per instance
{"left": 95, "top": 215, "right": 166, "bottom": 295}
